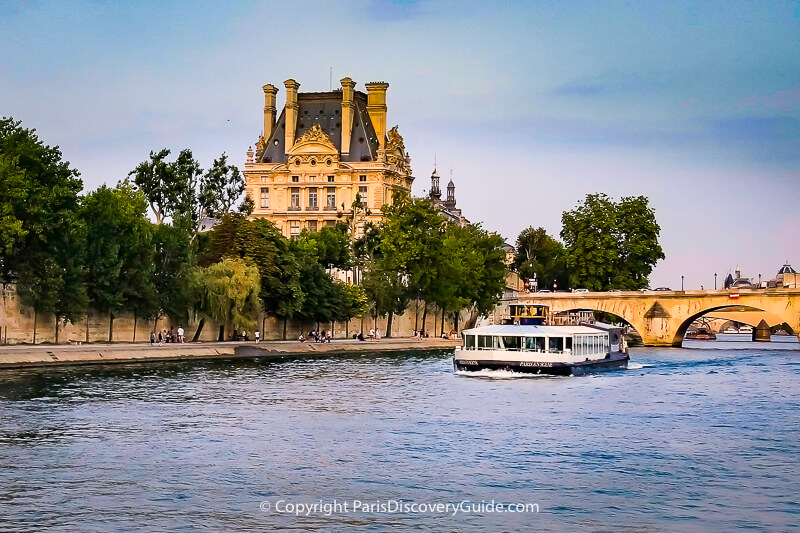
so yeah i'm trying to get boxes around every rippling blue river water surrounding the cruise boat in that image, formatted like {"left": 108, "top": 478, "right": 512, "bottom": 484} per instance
{"left": 0, "top": 338, "right": 800, "bottom": 532}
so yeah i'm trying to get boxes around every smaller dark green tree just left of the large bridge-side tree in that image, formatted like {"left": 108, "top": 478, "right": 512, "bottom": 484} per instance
{"left": 513, "top": 226, "right": 569, "bottom": 289}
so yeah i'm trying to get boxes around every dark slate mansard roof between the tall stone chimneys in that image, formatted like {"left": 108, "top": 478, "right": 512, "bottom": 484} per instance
{"left": 260, "top": 90, "right": 379, "bottom": 163}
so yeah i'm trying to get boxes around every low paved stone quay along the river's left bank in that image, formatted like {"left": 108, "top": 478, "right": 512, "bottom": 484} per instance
{"left": 0, "top": 338, "right": 461, "bottom": 370}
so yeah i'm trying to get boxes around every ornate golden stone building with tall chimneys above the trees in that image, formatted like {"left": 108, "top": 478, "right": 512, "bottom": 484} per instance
{"left": 244, "top": 78, "right": 414, "bottom": 237}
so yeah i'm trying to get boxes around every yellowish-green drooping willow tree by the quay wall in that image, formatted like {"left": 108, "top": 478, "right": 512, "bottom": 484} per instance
{"left": 193, "top": 257, "right": 261, "bottom": 340}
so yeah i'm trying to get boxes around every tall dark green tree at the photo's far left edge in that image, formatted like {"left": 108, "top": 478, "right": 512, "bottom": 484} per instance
{"left": 0, "top": 117, "right": 87, "bottom": 342}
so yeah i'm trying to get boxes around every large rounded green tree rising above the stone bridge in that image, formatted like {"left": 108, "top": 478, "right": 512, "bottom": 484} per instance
{"left": 561, "top": 194, "right": 664, "bottom": 290}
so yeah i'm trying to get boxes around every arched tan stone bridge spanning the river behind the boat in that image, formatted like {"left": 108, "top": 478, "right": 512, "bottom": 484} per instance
{"left": 506, "top": 289, "right": 800, "bottom": 346}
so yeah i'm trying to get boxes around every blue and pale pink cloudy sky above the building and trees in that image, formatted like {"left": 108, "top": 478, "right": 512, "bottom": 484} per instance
{"left": 0, "top": 0, "right": 800, "bottom": 290}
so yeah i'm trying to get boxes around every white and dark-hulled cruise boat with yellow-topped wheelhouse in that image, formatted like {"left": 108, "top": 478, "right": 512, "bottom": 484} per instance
{"left": 453, "top": 304, "right": 629, "bottom": 376}
